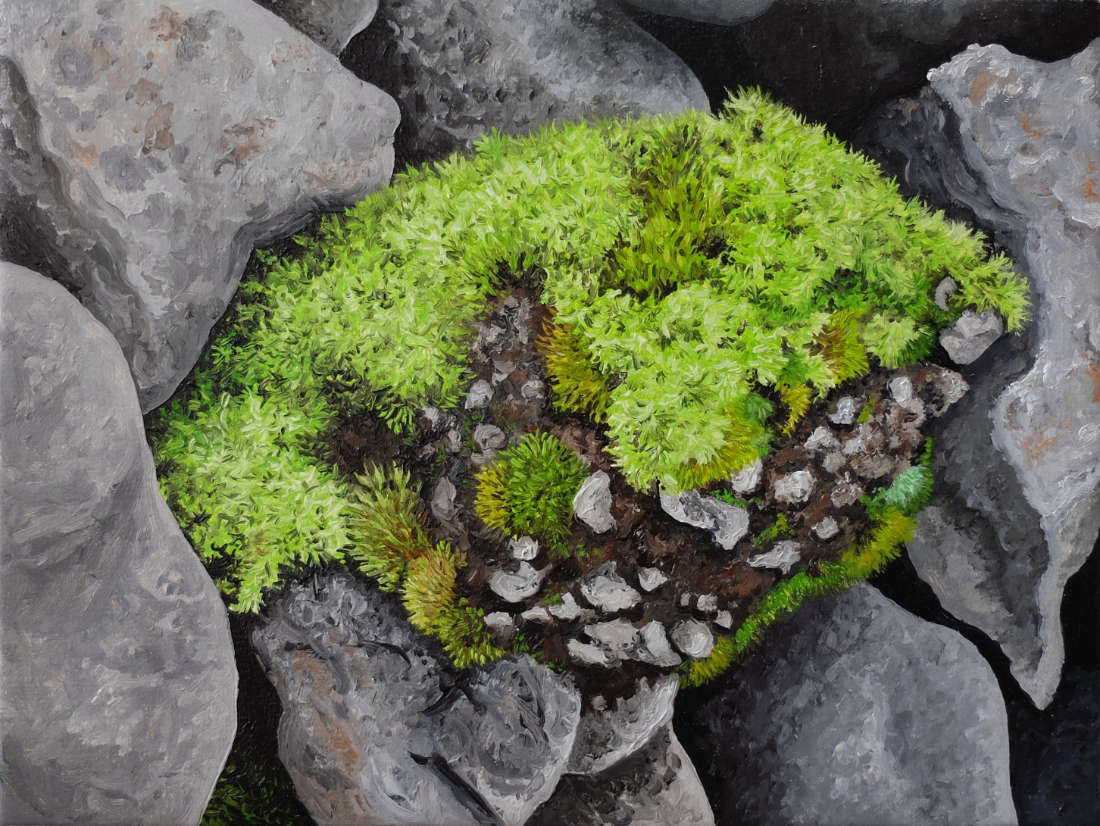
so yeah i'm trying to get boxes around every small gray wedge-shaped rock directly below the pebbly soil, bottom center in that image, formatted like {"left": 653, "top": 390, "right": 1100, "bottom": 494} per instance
{"left": 565, "top": 674, "right": 680, "bottom": 774}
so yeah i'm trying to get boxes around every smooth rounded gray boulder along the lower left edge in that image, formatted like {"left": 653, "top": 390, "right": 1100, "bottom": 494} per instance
{"left": 0, "top": 263, "right": 237, "bottom": 824}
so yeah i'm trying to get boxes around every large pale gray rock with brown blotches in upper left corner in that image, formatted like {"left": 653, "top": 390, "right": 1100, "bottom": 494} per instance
{"left": 0, "top": 0, "right": 398, "bottom": 410}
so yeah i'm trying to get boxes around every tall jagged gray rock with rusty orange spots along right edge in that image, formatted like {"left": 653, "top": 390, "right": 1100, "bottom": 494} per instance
{"left": 865, "top": 41, "right": 1100, "bottom": 707}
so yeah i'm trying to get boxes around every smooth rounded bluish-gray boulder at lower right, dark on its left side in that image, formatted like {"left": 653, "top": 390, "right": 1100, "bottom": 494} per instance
{"left": 692, "top": 585, "right": 1016, "bottom": 826}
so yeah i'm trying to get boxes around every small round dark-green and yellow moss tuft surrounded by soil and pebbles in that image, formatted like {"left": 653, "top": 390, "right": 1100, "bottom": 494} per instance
{"left": 474, "top": 432, "right": 589, "bottom": 555}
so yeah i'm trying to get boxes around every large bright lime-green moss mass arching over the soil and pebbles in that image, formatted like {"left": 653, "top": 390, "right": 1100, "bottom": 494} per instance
{"left": 151, "top": 90, "right": 1026, "bottom": 610}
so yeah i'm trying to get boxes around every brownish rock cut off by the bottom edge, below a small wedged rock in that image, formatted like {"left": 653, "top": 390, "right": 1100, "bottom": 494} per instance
{"left": 530, "top": 724, "right": 714, "bottom": 826}
